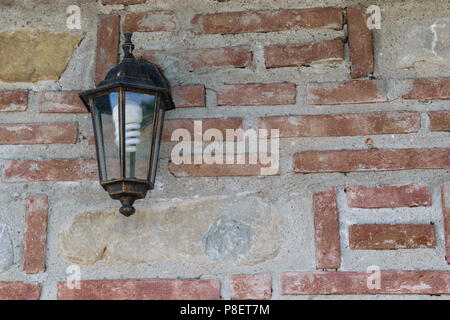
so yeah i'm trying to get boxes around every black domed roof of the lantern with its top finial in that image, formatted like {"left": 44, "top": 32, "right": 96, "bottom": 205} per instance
{"left": 80, "top": 32, "right": 175, "bottom": 110}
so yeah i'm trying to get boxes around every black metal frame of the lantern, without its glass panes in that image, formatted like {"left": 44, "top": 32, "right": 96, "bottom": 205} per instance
{"left": 79, "top": 32, "right": 175, "bottom": 216}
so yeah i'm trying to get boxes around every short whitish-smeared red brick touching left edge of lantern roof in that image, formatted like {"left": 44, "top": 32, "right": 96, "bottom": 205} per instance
{"left": 37, "top": 91, "right": 88, "bottom": 113}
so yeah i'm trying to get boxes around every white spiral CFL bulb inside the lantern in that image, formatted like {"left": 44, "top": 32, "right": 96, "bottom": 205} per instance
{"left": 112, "top": 100, "right": 143, "bottom": 152}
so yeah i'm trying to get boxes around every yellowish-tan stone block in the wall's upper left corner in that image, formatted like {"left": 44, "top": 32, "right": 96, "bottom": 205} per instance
{"left": 0, "top": 30, "right": 82, "bottom": 82}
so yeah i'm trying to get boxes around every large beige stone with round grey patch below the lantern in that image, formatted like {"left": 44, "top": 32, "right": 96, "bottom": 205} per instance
{"left": 59, "top": 195, "right": 281, "bottom": 265}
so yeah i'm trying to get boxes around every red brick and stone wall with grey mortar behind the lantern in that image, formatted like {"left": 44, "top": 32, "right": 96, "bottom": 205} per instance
{"left": 0, "top": 0, "right": 450, "bottom": 299}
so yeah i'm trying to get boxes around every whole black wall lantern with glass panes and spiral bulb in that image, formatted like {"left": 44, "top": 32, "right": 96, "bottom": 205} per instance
{"left": 80, "top": 33, "right": 175, "bottom": 216}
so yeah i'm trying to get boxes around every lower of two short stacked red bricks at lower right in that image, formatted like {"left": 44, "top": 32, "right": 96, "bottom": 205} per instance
{"left": 349, "top": 224, "right": 436, "bottom": 250}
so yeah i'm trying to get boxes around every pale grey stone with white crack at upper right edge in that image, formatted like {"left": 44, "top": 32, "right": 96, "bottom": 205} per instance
{"left": 398, "top": 18, "right": 450, "bottom": 68}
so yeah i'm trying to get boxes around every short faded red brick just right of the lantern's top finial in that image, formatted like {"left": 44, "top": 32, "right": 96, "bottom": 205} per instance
{"left": 181, "top": 46, "right": 252, "bottom": 71}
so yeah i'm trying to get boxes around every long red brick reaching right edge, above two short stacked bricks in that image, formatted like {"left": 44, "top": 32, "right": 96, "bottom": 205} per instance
{"left": 294, "top": 148, "right": 450, "bottom": 173}
